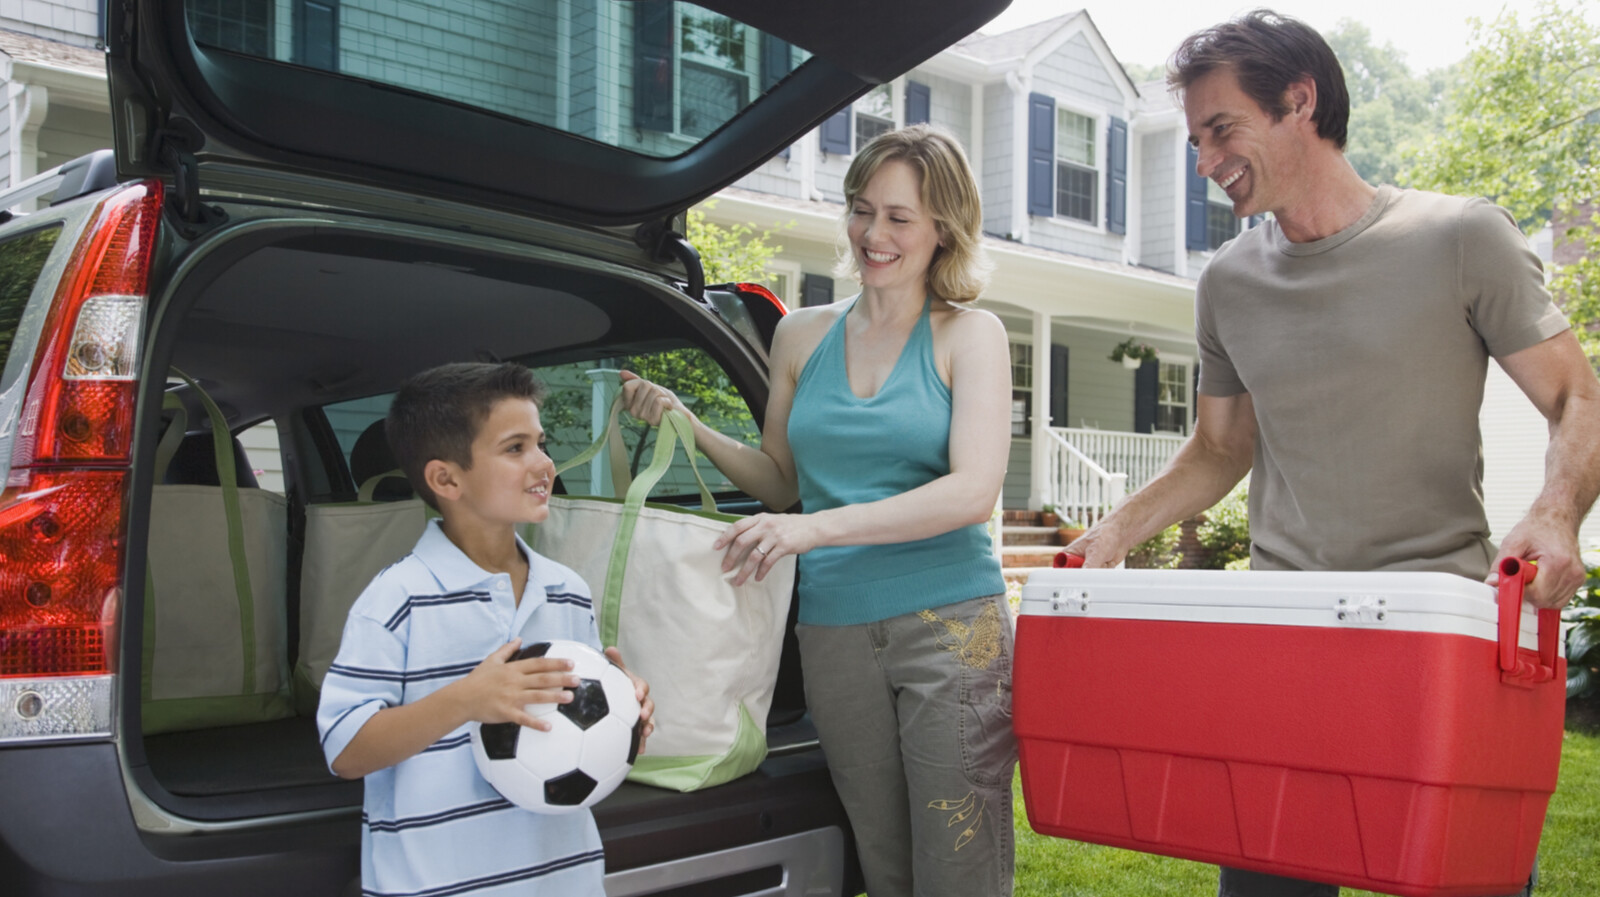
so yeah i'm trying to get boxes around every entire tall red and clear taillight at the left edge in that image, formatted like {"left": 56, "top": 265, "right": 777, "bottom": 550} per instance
{"left": 0, "top": 181, "right": 162, "bottom": 740}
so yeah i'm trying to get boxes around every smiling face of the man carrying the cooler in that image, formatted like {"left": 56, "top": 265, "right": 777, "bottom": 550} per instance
{"left": 1184, "top": 67, "right": 1302, "bottom": 217}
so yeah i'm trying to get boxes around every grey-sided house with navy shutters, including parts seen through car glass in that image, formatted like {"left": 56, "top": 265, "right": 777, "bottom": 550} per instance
{"left": 0, "top": 0, "right": 1574, "bottom": 546}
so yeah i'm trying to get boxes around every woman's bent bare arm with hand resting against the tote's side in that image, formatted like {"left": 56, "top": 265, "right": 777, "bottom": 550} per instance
{"left": 714, "top": 310, "right": 1011, "bottom": 584}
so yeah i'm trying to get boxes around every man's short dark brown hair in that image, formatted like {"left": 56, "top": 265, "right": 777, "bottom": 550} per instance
{"left": 1166, "top": 10, "right": 1350, "bottom": 149}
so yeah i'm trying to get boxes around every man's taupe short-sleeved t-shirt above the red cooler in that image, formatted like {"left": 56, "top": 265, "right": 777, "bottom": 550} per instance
{"left": 1195, "top": 187, "right": 1568, "bottom": 579}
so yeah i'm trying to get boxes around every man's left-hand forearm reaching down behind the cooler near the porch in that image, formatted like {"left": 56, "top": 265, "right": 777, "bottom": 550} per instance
{"left": 1067, "top": 392, "right": 1256, "bottom": 568}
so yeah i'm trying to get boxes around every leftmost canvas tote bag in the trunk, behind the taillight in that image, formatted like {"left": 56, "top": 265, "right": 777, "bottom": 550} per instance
{"left": 141, "top": 374, "right": 294, "bottom": 734}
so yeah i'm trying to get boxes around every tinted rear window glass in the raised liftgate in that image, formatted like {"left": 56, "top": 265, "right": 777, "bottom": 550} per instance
{"left": 186, "top": 0, "right": 808, "bottom": 157}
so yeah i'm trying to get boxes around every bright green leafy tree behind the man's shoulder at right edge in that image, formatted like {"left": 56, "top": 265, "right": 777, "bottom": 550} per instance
{"left": 1406, "top": 0, "right": 1600, "bottom": 358}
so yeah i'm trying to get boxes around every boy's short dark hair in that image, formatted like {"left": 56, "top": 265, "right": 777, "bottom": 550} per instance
{"left": 384, "top": 361, "right": 544, "bottom": 510}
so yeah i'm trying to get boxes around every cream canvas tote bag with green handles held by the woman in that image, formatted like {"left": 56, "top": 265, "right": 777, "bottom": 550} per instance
{"left": 531, "top": 405, "right": 795, "bottom": 791}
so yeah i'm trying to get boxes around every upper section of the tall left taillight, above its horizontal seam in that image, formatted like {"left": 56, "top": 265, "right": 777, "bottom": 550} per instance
{"left": 11, "top": 181, "right": 162, "bottom": 463}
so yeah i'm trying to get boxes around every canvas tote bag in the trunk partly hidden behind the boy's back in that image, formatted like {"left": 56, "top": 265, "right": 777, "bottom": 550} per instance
{"left": 294, "top": 470, "right": 429, "bottom": 716}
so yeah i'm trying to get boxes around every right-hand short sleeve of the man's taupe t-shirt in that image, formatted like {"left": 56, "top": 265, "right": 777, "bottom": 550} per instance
{"left": 1459, "top": 200, "right": 1571, "bottom": 358}
